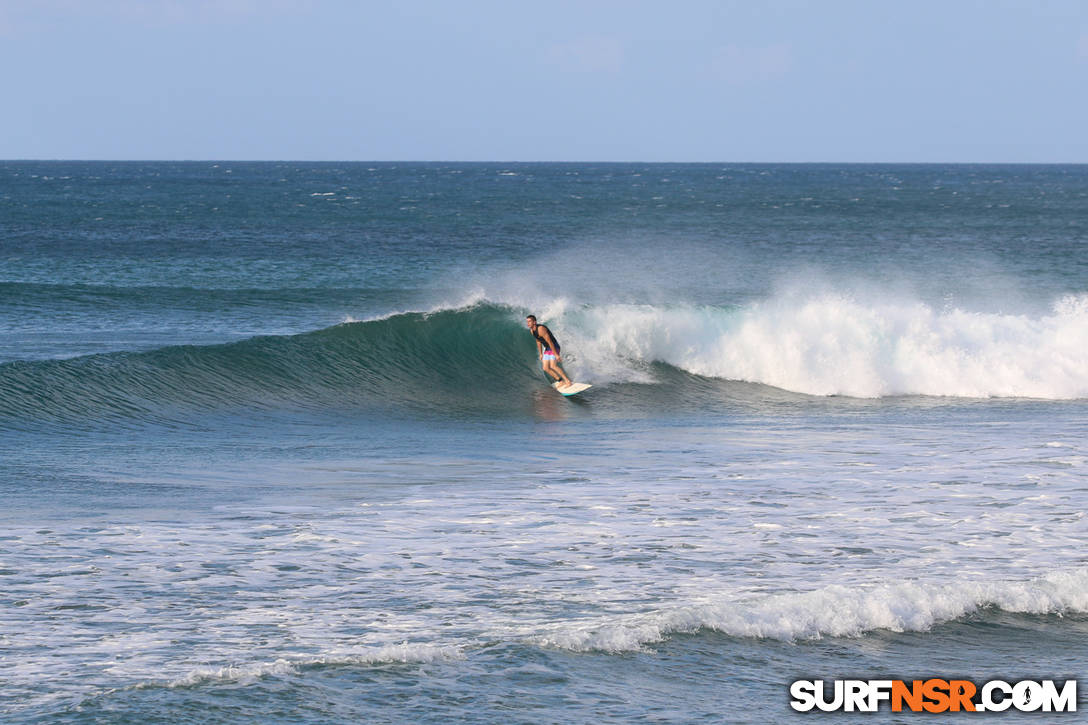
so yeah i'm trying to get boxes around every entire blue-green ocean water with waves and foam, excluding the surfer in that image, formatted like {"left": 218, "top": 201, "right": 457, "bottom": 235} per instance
{"left": 0, "top": 162, "right": 1088, "bottom": 723}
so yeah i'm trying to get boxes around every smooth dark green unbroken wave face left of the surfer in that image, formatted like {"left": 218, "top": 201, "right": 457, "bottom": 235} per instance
{"left": 0, "top": 307, "right": 533, "bottom": 425}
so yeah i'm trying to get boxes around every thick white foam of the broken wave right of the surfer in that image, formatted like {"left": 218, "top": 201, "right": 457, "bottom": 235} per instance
{"left": 552, "top": 294, "right": 1088, "bottom": 400}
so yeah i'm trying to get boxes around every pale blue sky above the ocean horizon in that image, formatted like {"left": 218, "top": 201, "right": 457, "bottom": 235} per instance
{"left": 0, "top": 0, "right": 1088, "bottom": 163}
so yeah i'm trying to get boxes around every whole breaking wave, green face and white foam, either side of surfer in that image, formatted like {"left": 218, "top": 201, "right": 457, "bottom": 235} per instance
{"left": 0, "top": 295, "right": 1088, "bottom": 422}
